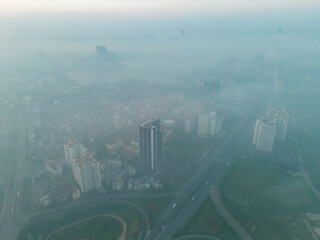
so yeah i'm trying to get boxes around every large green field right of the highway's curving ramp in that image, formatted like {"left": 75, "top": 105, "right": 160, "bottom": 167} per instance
{"left": 221, "top": 156, "right": 320, "bottom": 240}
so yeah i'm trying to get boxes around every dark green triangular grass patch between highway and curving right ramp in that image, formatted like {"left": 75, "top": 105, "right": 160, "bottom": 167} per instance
{"left": 176, "top": 197, "right": 236, "bottom": 239}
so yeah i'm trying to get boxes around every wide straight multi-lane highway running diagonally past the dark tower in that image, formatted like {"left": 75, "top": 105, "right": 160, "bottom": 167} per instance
{"left": 146, "top": 96, "right": 261, "bottom": 240}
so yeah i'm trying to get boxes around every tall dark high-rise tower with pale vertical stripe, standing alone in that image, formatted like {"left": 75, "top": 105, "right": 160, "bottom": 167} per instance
{"left": 139, "top": 118, "right": 162, "bottom": 171}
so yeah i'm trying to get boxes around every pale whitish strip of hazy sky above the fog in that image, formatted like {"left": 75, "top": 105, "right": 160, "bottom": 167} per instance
{"left": 0, "top": 0, "right": 320, "bottom": 16}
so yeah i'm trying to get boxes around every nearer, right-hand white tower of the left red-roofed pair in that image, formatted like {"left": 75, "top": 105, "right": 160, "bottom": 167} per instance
{"left": 72, "top": 153, "right": 101, "bottom": 193}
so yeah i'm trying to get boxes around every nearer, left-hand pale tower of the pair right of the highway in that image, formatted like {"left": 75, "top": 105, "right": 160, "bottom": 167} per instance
{"left": 252, "top": 118, "right": 277, "bottom": 152}
